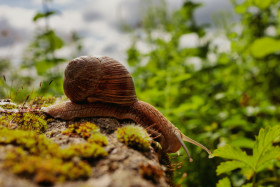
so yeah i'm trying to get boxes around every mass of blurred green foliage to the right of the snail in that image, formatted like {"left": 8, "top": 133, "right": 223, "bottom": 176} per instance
{"left": 127, "top": 0, "right": 280, "bottom": 186}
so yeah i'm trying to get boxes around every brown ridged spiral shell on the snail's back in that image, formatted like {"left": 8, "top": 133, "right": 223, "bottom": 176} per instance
{"left": 63, "top": 56, "right": 137, "bottom": 105}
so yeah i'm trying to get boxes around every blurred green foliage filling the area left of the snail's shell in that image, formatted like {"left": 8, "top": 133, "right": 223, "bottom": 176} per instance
{"left": 0, "top": 0, "right": 82, "bottom": 102}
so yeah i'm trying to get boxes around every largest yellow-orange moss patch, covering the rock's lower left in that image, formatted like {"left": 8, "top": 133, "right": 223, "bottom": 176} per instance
{"left": 0, "top": 128, "right": 99, "bottom": 185}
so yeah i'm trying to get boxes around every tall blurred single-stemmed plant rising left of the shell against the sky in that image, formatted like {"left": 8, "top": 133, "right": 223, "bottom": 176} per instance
{"left": 22, "top": 0, "right": 66, "bottom": 95}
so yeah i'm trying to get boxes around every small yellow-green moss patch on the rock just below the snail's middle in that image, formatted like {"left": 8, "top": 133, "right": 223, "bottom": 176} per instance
{"left": 62, "top": 122, "right": 99, "bottom": 139}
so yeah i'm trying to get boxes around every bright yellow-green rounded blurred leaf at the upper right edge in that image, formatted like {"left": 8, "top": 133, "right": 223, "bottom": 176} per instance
{"left": 251, "top": 37, "right": 280, "bottom": 58}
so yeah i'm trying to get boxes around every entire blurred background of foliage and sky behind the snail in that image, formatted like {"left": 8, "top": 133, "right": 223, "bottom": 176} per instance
{"left": 0, "top": 0, "right": 280, "bottom": 186}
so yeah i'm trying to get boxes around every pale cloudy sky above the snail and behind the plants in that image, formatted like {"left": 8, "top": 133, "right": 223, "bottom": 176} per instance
{"left": 0, "top": 0, "right": 232, "bottom": 64}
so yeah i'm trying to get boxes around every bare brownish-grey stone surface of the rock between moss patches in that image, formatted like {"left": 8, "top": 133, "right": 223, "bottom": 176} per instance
{"left": 0, "top": 110, "right": 169, "bottom": 187}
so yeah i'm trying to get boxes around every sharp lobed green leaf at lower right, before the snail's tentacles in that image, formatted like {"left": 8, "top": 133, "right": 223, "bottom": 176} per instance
{"left": 214, "top": 125, "right": 280, "bottom": 187}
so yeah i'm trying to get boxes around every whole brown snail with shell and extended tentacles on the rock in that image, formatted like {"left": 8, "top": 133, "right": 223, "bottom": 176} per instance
{"left": 43, "top": 56, "right": 211, "bottom": 161}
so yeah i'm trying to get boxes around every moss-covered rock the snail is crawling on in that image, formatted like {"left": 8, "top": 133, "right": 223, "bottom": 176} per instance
{"left": 0, "top": 109, "right": 167, "bottom": 186}
